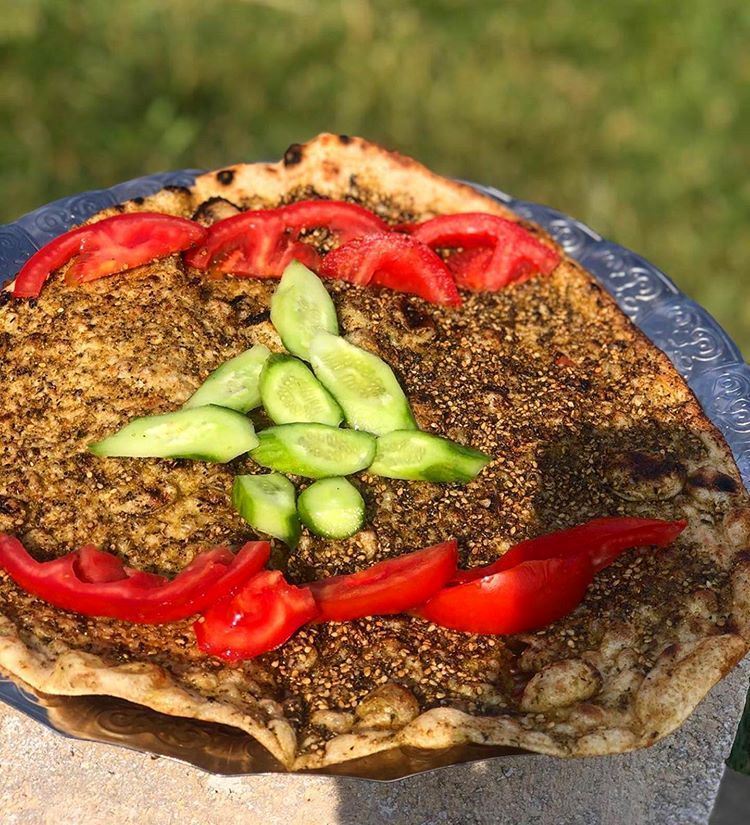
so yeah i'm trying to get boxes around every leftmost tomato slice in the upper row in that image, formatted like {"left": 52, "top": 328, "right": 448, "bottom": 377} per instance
{"left": 13, "top": 212, "right": 206, "bottom": 298}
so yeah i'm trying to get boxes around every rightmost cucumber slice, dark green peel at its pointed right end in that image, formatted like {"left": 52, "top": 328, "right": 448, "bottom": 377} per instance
{"left": 368, "top": 430, "right": 492, "bottom": 483}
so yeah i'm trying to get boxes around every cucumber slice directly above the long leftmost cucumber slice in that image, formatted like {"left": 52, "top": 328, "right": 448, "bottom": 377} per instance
{"left": 183, "top": 344, "right": 271, "bottom": 412}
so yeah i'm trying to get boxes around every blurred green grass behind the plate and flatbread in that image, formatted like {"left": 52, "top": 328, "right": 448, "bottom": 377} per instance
{"left": 0, "top": 0, "right": 750, "bottom": 354}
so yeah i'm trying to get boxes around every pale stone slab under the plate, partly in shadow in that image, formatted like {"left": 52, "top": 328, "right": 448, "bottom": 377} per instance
{"left": 0, "top": 660, "right": 750, "bottom": 825}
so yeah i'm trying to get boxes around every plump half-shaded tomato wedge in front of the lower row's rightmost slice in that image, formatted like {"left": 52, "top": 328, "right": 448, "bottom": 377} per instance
{"left": 412, "top": 555, "right": 594, "bottom": 634}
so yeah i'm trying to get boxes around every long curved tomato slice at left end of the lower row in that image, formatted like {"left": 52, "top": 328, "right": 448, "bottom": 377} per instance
{"left": 0, "top": 535, "right": 270, "bottom": 624}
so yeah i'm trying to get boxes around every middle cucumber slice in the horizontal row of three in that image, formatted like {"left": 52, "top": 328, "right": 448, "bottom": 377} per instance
{"left": 250, "top": 424, "right": 375, "bottom": 478}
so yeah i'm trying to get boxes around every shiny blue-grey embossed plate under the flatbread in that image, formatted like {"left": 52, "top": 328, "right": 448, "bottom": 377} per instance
{"left": 0, "top": 169, "right": 750, "bottom": 779}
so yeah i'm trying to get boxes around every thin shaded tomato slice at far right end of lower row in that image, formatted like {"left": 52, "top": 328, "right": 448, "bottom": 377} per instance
{"left": 452, "top": 516, "right": 687, "bottom": 584}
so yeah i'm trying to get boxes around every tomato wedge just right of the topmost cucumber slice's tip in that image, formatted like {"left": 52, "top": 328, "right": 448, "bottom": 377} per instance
{"left": 320, "top": 232, "right": 461, "bottom": 306}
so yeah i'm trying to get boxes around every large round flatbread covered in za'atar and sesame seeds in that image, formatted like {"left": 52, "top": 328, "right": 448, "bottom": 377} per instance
{"left": 0, "top": 135, "right": 750, "bottom": 770}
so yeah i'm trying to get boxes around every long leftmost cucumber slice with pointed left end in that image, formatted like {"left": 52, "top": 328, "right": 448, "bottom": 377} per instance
{"left": 89, "top": 405, "right": 258, "bottom": 464}
